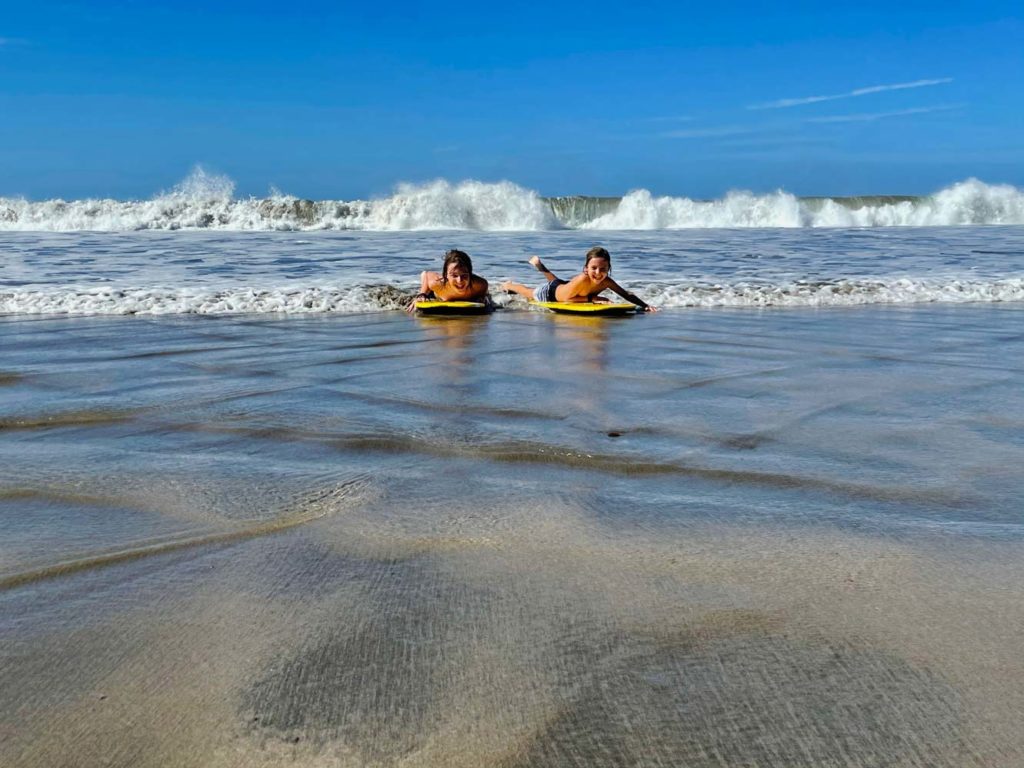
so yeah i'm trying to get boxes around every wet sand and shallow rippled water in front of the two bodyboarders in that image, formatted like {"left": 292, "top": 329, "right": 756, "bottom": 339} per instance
{"left": 0, "top": 304, "right": 1024, "bottom": 766}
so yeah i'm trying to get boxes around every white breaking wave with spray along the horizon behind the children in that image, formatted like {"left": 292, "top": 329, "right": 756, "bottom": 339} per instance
{"left": 0, "top": 168, "right": 1024, "bottom": 231}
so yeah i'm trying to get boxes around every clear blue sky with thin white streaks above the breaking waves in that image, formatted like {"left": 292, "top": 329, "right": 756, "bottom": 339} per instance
{"left": 0, "top": 0, "right": 1024, "bottom": 200}
